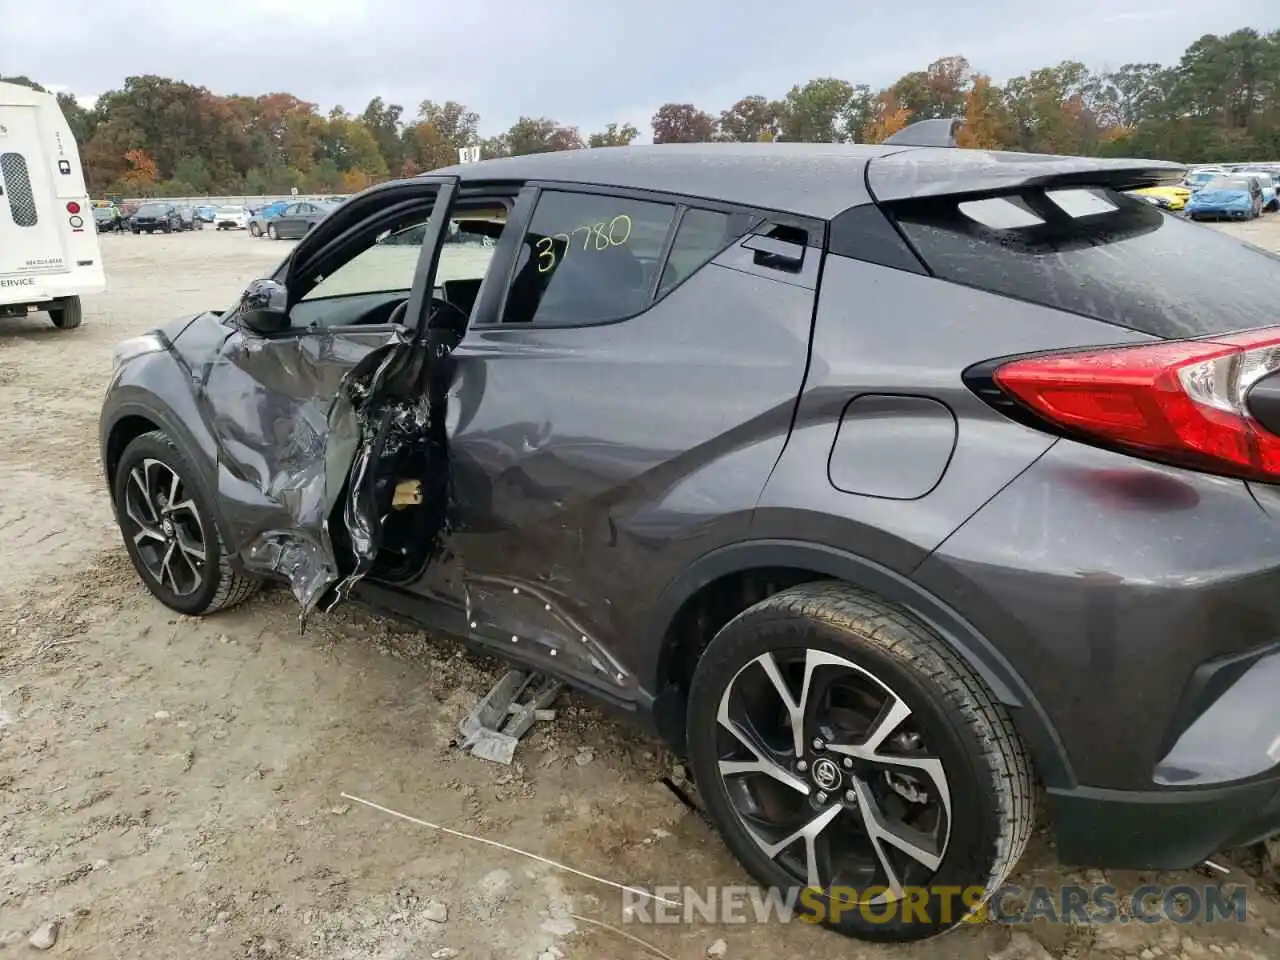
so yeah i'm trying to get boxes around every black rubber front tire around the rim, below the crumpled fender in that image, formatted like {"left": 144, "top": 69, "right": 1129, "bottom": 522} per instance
{"left": 111, "top": 430, "right": 261, "bottom": 617}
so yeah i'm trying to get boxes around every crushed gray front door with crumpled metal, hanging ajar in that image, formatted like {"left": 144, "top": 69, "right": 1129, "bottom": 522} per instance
{"left": 198, "top": 177, "right": 457, "bottom": 620}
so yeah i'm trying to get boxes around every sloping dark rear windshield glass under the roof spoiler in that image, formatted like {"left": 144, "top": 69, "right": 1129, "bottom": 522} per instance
{"left": 893, "top": 188, "right": 1280, "bottom": 339}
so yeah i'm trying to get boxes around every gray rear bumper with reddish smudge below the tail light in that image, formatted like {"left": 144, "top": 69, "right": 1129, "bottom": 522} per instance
{"left": 914, "top": 439, "right": 1280, "bottom": 869}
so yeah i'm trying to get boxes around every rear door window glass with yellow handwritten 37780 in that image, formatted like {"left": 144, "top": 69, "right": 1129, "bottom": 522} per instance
{"left": 502, "top": 191, "right": 676, "bottom": 324}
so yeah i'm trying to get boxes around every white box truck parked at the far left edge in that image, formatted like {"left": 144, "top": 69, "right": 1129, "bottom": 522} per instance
{"left": 0, "top": 83, "right": 106, "bottom": 330}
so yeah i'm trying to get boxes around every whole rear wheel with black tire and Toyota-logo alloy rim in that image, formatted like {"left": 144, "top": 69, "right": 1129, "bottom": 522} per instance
{"left": 687, "top": 582, "right": 1033, "bottom": 941}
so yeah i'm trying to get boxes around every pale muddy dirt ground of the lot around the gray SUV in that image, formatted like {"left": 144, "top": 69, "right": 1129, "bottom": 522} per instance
{"left": 0, "top": 216, "right": 1280, "bottom": 960}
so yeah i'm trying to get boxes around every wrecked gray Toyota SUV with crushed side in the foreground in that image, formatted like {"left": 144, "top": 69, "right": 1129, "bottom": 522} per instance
{"left": 94, "top": 128, "right": 1280, "bottom": 940}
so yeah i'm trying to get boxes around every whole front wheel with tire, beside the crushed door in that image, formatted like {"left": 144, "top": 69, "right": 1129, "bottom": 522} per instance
{"left": 111, "top": 430, "right": 259, "bottom": 616}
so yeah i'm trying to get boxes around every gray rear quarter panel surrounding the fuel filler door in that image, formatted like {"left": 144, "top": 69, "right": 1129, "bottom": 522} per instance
{"left": 753, "top": 255, "right": 1149, "bottom": 573}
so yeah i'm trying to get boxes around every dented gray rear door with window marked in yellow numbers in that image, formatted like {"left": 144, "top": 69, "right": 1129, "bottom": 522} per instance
{"left": 415, "top": 184, "right": 824, "bottom": 701}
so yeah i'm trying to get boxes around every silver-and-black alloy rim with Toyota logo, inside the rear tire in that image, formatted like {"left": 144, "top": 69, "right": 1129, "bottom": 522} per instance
{"left": 717, "top": 649, "right": 951, "bottom": 904}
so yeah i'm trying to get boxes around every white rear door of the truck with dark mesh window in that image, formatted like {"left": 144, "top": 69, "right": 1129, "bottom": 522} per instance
{"left": 0, "top": 104, "right": 67, "bottom": 284}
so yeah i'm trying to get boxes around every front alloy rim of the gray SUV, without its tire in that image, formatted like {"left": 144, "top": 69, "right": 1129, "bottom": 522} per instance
{"left": 120, "top": 458, "right": 207, "bottom": 596}
